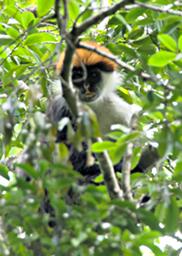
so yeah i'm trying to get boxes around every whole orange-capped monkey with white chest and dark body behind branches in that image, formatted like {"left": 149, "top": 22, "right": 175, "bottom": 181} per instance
{"left": 48, "top": 41, "right": 159, "bottom": 181}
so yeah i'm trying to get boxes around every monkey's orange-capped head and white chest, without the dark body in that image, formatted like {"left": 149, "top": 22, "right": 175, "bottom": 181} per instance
{"left": 57, "top": 42, "right": 138, "bottom": 134}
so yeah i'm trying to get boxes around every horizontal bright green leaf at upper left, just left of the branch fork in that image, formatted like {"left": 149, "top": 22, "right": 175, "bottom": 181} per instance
{"left": 25, "top": 32, "right": 56, "bottom": 45}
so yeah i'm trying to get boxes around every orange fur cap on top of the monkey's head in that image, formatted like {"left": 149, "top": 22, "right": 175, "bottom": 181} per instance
{"left": 56, "top": 42, "right": 117, "bottom": 74}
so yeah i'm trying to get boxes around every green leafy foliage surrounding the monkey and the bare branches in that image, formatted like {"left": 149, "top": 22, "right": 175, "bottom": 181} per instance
{"left": 0, "top": 0, "right": 182, "bottom": 256}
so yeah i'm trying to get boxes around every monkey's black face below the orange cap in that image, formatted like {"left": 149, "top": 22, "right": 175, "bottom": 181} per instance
{"left": 72, "top": 66, "right": 103, "bottom": 102}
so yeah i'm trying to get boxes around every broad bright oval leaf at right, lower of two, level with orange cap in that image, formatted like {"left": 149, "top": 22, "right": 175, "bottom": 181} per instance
{"left": 148, "top": 51, "right": 176, "bottom": 67}
